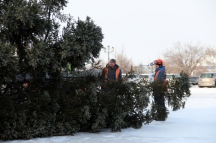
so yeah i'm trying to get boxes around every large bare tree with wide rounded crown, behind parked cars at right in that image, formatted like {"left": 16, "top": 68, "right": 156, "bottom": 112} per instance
{"left": 164, "top": 42, "right": 212, "bottom": 75}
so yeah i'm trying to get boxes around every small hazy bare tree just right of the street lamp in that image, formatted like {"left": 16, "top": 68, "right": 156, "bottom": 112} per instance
{"left": 115, "top": 49, "right": 133, "bottom": 73}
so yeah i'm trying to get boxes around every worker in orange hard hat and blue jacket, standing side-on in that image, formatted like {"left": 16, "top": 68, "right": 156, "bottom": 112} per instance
{"left": 153, "top": 59, "right": 168, "bottom": 121}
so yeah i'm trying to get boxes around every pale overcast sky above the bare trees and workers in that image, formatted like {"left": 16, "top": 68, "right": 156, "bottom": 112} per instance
{"left": 64, "top": 0, "right": 216, "bottom": 64}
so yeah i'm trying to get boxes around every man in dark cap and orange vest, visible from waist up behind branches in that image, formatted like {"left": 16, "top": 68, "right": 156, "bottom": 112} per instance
{"left": 102, "top": 59, "right": 122, "bottom": 82}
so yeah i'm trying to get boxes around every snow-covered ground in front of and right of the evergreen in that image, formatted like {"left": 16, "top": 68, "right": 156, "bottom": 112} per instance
{"left": 0, "top": 87, "right": 216, "bottom": 143}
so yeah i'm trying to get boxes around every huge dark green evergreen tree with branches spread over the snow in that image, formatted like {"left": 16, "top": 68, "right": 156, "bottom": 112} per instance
{"left": 0, "top": 0, "right": 190, "bottom": 140}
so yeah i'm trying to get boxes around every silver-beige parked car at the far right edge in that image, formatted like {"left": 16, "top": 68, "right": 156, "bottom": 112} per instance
{"left": 198, "top": 72, "right": 216, "bottom": 88}
